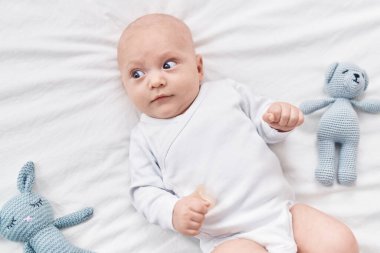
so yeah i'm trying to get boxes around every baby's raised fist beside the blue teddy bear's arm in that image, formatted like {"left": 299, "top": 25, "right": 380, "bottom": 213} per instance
{"left": 263, "top": 102, "right": 304, "bottom": 132}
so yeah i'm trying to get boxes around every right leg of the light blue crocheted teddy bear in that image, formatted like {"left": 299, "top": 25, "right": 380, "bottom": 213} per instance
{"left": 338, "top": 142, "right": 358, "bottom": 185}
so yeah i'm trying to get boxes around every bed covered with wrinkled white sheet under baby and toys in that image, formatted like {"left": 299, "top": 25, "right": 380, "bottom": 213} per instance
{"left": 0, "top": 0, "right": 380, "bottom": 253}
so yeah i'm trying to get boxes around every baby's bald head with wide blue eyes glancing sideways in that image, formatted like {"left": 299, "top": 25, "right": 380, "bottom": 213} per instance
{"left": 118, "top": 14, "right": 203, "bottom": 118}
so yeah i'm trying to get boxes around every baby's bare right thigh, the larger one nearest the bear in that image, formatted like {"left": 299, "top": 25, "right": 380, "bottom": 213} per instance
{"left": 291, "top": 204, "right": 359, "bottom": 253}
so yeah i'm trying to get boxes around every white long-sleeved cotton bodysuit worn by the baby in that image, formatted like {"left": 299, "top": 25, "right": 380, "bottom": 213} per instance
{"left": 129, "top": 80, "right": 297, "bottom": 253}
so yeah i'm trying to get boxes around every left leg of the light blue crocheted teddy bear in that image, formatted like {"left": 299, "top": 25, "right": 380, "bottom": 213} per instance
{"left": 315, "top": 140, "right": 335, "bottom": 186}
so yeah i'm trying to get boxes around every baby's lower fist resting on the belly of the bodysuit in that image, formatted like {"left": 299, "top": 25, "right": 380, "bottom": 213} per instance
{"left": 173, "top": 190, "right": 211, "bottom": 236}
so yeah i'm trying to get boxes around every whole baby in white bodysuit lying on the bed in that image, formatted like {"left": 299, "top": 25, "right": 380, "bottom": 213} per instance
{"left": 118, "top": 14, "right": 358, "bottom": 253}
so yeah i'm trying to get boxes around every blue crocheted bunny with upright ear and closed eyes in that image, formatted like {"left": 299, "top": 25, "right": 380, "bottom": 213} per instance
{"left": 0, "top": 162, "right": 93, "bottom": 253}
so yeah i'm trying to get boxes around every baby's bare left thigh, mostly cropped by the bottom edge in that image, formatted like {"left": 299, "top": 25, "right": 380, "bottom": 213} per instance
{"left": 212, "top": 239, "right": 268, "bottom": 253}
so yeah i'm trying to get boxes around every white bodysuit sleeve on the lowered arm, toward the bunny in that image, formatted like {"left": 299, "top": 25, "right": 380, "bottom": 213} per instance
{"left": 129, "top": 129, "right": 178, "bottom": 230}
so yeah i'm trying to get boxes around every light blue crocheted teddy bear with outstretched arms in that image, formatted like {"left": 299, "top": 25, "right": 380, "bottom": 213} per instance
{"left": 300, "top": 63, "right": 380, "bottom": 186}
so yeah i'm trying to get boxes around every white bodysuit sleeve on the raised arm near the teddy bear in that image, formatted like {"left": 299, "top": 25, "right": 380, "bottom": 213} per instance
{"left": 233, "top": 82, "right": 289, "bottom": 144}
